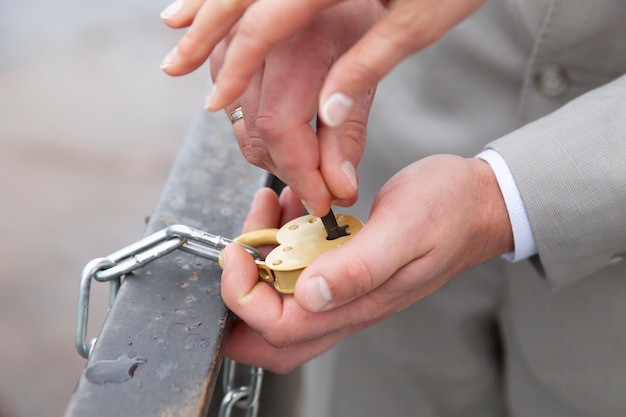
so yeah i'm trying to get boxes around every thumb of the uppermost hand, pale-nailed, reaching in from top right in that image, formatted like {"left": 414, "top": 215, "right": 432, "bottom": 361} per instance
{"left": 319, "top": 0, "right": 484, "bottom": 126}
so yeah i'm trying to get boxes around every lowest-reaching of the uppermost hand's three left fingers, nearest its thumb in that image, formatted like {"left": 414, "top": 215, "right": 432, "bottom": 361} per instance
{"left": 207, "top": 0, "right": 340, "bottom": 111}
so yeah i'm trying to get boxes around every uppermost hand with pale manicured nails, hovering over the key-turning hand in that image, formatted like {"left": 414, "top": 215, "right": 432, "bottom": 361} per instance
{"left": 162, "top": 0, "right": 485, "bottom": 120}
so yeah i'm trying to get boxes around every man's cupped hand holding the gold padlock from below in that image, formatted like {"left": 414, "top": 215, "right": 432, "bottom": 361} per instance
{"left": 222, "top": 155, "right": 513, "bottom": 372}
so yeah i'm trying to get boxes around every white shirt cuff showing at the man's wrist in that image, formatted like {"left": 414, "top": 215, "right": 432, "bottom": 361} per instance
{"left": 476, "top": 149, "right": 537, "bottom": 262}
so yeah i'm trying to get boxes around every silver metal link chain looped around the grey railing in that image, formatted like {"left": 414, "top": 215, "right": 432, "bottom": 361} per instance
{"left": 74, "top": 225, "right": 263, "bottom": 417}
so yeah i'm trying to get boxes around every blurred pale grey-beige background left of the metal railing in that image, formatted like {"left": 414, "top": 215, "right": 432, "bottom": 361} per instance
{"left": 0, "top": 0, "right": 209, "bottom": 417}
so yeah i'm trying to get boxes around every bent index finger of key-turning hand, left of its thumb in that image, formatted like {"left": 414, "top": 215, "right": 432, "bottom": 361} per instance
{"left": 249, "top": 31, "right": 334, "bottom": 216}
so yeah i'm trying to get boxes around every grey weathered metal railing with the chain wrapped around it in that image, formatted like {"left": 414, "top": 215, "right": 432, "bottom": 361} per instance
{"left": 65, "top": 112, "right": 296, "bottom": 417}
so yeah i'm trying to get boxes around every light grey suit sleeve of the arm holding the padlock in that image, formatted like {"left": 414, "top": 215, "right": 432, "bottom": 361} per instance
{"left": 488, "top": 75, "right": 626, "bottom": 288}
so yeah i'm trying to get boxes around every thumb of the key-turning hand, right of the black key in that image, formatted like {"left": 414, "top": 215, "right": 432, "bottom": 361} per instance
{"left": 317, "top": 86, "right": 374, "bottom": 202}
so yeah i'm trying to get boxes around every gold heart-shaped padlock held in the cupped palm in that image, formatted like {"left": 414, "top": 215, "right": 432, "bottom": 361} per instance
{"left": 220, "top": 214, "right": 363, "bottom": 294}
